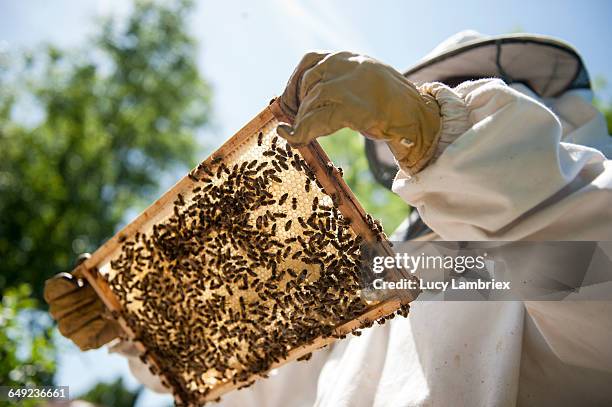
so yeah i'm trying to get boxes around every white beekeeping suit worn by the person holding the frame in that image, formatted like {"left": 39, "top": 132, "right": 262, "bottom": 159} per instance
{"left": 120, "top": 32, "right": 612, "bottom": 407}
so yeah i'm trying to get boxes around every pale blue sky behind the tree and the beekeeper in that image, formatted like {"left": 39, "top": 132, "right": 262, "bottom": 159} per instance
{"left": 0, "top": 0, "right": 612, "bottom": 406}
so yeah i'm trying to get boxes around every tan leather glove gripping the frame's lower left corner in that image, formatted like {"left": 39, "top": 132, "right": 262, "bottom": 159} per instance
{"left": 44, "top": 255, "right": 121, "bottom": 350}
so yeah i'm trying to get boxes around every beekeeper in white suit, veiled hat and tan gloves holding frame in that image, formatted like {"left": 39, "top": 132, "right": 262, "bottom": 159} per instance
{"left": 47, "top": 32, "right": 612, "bottom": 407}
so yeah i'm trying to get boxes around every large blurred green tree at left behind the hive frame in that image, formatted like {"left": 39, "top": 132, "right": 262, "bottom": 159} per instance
{"left": 0, "top": 1, "right": 210, "bottom": 298}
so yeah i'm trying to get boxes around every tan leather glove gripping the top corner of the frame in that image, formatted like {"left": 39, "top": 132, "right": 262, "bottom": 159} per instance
{"left": 278, "top": 52, "right": 440, "bottom": 174}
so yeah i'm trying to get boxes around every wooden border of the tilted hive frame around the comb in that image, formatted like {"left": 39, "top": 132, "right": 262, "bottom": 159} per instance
{"left": 73, "top": 100, "right": 419, "bottom": 403}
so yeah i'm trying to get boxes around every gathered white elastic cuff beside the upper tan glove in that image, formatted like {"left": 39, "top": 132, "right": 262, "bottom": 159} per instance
{"left": 419, "top": 82, "right": 471, "bottom": 165}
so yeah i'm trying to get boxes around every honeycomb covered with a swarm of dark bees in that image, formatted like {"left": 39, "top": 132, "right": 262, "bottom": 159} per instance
{"left": 103, "top": 120, "right": 408, "bottom": 405}
